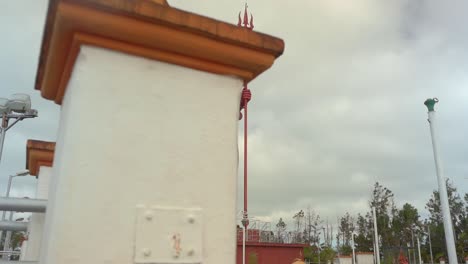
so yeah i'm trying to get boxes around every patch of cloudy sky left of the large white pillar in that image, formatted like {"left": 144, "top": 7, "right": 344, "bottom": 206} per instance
{"left": 0, "top": 0, "right": 55, "bottom": 197}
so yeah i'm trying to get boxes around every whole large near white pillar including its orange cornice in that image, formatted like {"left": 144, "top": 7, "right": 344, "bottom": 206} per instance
{"left": 37, "top": 0, "right": 284, "bottom": 264}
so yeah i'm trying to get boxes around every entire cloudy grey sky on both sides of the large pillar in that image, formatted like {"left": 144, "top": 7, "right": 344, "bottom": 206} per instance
{"left": 0, "top": 0, "right": 468, "bottom": 229}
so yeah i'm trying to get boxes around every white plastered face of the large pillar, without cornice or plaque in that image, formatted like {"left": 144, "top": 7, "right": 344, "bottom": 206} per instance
{"left": 40, "top": 46, "right": 242, "bottom": 264}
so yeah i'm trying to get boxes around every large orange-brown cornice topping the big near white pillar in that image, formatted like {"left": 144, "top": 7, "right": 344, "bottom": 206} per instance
{"left": 36, "top": 0, "right": 284, "bottom": 104}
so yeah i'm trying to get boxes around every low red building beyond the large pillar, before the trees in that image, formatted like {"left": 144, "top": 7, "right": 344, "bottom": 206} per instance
{"left": 236, "top": 229, "right": 307, "bottom": 264}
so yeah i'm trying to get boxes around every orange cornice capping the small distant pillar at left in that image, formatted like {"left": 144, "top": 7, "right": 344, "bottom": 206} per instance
{"left": 26, "top": 139, "right": 55, "bottom": 177}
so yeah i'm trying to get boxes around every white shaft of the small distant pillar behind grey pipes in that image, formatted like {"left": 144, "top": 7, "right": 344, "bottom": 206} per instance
{"left": 21, "top": 166, "right": 52, "bottom": 261}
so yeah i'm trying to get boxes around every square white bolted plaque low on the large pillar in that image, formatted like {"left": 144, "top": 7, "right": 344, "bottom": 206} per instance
{"left": 134, "top": 206, "right": 203, "bottom": 264}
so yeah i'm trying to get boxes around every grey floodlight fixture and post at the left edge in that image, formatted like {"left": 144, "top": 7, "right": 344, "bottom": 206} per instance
{"left": 0, "top": 94, "right": 37, "bottom": 161}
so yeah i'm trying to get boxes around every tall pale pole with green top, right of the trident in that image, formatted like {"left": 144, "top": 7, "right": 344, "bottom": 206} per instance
{"left": 424, "top": 98, "right": 458, "bottom": 264}
